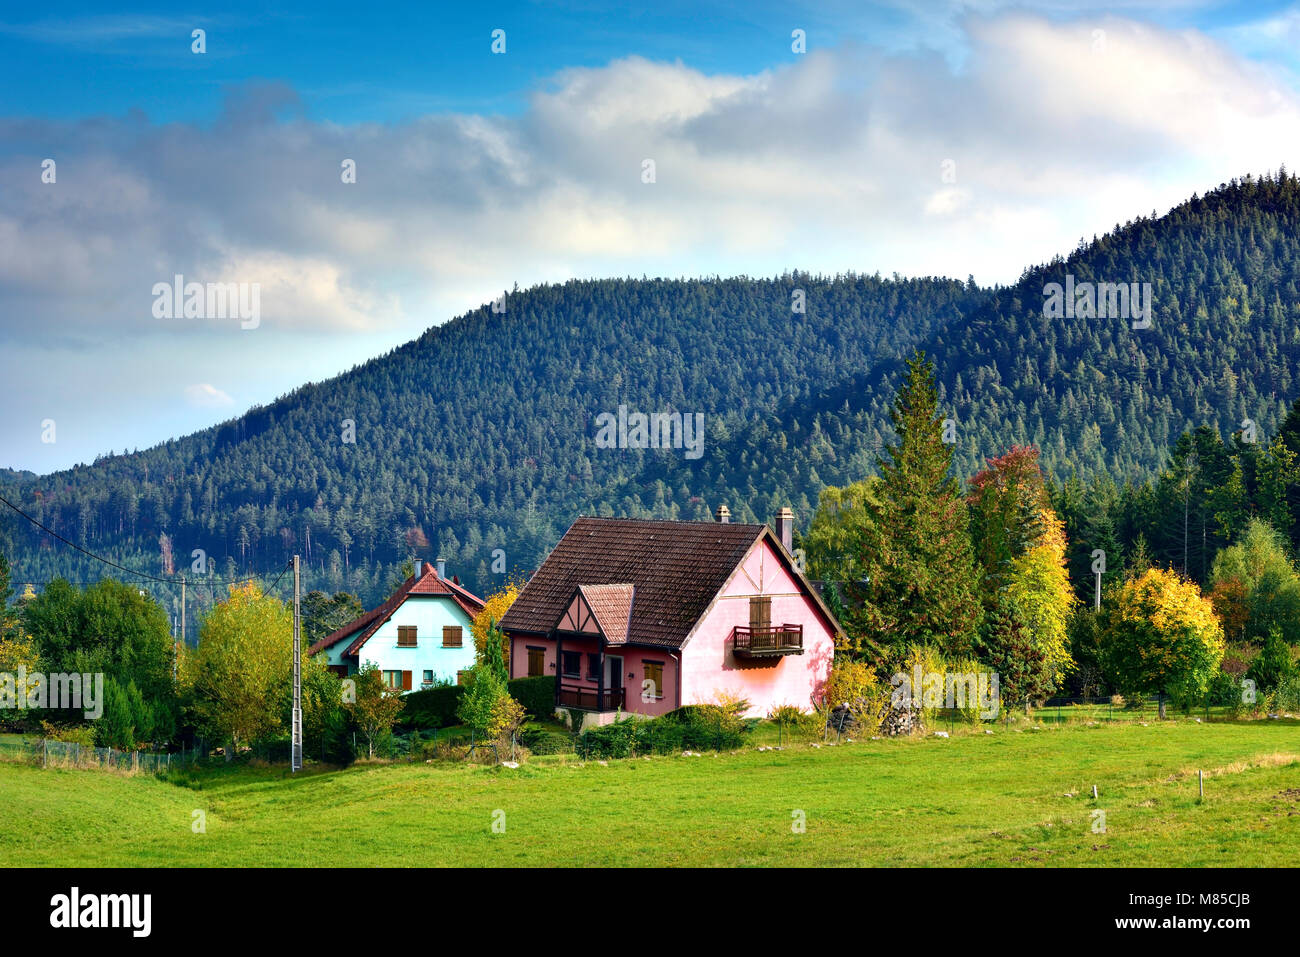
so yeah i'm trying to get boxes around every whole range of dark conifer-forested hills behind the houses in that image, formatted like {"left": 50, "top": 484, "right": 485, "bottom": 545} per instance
{"left": 0, "top": 176, "right": 1300, "bottom": 606}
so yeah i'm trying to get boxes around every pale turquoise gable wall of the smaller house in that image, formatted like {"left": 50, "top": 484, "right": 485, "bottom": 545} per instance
{"left": 325, "top": 594, "right": 480, "bottom": 692}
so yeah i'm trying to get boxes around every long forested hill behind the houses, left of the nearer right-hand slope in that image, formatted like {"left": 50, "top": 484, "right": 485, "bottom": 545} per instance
{"left": 0, "top": 274, "right": 987, "bottom": 606}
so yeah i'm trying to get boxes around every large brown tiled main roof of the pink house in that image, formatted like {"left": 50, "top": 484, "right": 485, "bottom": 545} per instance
{"left": 501, "top": 518, "right": 837, "bottom": 648}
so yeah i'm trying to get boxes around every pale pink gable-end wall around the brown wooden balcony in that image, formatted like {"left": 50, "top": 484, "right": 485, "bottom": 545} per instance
{"left": 681, "top": 540, "right": 835, "bottom": 718}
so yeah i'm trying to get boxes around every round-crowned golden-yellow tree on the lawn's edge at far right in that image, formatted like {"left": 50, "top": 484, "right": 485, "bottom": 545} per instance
{"left": 1101, "top": 568, "right": 1223, "bottom": 702}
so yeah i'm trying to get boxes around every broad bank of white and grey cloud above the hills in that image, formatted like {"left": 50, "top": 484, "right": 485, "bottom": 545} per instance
{"left": 0, "top": 13, "right": 1300, "bottom": 468}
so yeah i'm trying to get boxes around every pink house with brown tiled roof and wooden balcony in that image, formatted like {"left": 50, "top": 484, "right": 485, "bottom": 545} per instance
{"left": 501, "top": 506, "right": 841, "bottom": 723}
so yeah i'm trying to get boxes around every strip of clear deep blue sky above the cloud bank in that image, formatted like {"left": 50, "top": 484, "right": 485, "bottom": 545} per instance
{"left": 10, "top": 0, "right": 1296, "bottom": 124}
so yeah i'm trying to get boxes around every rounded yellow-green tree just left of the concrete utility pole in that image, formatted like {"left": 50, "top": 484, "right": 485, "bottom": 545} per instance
{"left": 181, "top": 581, "right": 294, "bottom": 761}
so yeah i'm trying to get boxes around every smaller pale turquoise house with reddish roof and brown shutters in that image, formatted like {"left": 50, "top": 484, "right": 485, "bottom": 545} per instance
{"left": 307, "top": 560, "right": 484, "bottom": 692}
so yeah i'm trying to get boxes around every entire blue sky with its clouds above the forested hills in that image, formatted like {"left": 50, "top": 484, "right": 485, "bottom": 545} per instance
{"left": 0, "top": 0, "right": 1300, "bottom": 472}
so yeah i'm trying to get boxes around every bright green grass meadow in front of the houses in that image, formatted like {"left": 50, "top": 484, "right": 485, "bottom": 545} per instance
{"left": 0, "top": 718, "right": 1300, "bottom": 866}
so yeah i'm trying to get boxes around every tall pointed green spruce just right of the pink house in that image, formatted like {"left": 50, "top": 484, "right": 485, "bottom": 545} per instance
{"left": 844, "top": 352, "right": 982, "bottom": 655}
